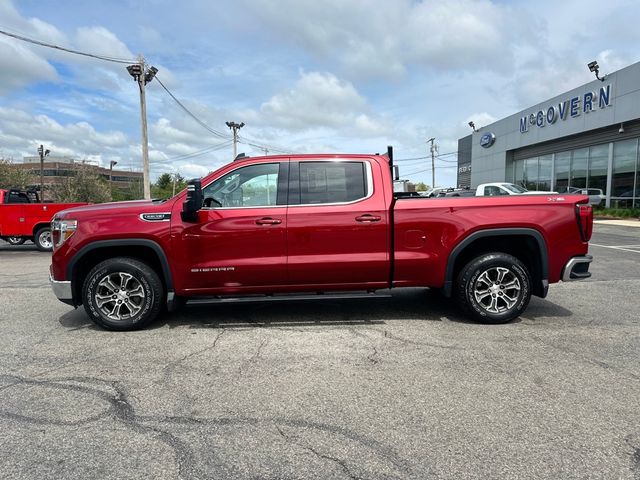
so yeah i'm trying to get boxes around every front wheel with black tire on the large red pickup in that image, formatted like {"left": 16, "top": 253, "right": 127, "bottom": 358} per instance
{"left": 82, "top": 257, "right": 165, "bottom": 331}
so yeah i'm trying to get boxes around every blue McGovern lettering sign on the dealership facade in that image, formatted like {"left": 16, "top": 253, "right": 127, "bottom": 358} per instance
{"left": 520, "top": 84, "right": 611, "bottom": 133}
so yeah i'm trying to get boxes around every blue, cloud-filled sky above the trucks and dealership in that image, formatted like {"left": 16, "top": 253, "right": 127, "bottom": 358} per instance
{"left": 0, "top": 0, "right": 640, "bottom": 186}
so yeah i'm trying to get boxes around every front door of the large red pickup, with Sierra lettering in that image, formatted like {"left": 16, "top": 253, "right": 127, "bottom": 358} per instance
{"left": 174, "top": 162, "right": 289, "bottom": 294}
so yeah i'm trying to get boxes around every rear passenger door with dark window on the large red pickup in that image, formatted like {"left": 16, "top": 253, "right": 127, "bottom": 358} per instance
{"left": 287, "top": 158, "right": 390, "bottom": 289}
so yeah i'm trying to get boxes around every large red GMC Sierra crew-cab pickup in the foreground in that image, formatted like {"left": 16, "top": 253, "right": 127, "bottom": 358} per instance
{"left": 50, "top": 150, "right": 593, "bottom": 330}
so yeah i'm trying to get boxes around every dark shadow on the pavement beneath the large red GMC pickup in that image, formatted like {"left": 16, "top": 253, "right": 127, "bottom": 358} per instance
{"left": 60, "top": 289, "right": 573, "bottom": 330}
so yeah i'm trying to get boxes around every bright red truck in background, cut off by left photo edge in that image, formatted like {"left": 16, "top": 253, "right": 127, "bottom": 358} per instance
{"left": 0, "top": 189, "right": 86, "bottom": 251}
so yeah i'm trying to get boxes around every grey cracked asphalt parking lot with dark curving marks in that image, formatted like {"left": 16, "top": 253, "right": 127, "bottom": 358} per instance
{"left": 0, "top": 223, "right": 640, "bottom": 480}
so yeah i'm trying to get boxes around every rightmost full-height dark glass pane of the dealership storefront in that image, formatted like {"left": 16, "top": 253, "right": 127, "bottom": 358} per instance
{"left": 611, "top": 138, "right": 638, "bottom": 208}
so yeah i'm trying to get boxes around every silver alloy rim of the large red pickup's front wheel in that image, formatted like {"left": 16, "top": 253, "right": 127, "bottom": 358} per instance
{"left": 94, "top": 272, "right": 146, "bottom": 321}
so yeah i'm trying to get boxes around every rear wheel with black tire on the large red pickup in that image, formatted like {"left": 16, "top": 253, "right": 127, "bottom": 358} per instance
{"left": 456, "top": 252, "right": 531, "bottom": 324}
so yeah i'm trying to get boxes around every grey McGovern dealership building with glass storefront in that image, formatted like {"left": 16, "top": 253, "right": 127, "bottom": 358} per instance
{"left": 458, "top": 62, "right": 640, "bottom": 208}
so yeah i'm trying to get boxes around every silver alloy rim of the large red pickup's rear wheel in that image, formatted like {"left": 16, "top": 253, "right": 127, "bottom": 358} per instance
{"left": 473, "top": 267, "right": 522, "bottom": 313}
